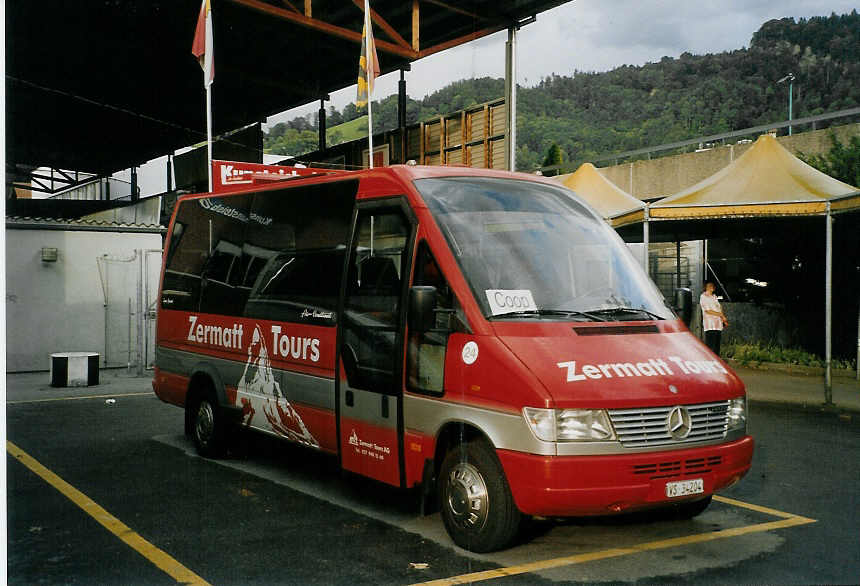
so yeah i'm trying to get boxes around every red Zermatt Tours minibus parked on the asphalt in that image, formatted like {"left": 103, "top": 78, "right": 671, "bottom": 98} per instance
{"left": 153, "top": 163, "right": 753, "bottom": 552}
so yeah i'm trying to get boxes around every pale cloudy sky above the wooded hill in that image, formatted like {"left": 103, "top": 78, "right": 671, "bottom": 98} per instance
{"left": 266, "top": 0, "right": 860, "bottom": 127}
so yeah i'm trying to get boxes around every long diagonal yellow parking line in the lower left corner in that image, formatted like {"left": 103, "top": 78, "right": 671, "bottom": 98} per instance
{"left": 6, "top": 440, "right": 209, "bottom": 586}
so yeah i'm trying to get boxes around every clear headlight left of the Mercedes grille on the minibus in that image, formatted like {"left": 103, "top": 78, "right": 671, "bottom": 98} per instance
{"left": 523, "top": 407, "right": 615, "bottom": 442}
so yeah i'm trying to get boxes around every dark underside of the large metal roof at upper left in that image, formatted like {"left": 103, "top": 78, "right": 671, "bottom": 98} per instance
{"left": 6, "top": 0, "right": 568, "bottom": 175}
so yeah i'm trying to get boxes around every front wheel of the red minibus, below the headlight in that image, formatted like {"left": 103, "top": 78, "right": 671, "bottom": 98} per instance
{"left": 439, "top": 440, "right": 522, "bottom": 553}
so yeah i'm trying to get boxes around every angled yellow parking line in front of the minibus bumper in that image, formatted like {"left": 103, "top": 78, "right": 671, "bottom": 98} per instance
{"left": 413, "top": 496, "right": 816, "bottom": 586}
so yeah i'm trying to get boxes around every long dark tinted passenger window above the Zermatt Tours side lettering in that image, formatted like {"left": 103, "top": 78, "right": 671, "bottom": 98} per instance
{"left": 162, "top": 181, "right": 357, "bottom": 323}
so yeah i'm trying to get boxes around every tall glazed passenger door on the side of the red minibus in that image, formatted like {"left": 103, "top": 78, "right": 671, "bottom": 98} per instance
{"left": 337, "top": 200, "right": 414, "bottom": 485}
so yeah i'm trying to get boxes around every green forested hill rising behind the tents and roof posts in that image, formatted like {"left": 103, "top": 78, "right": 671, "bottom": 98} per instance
{"left": 265, "top": 10, "right": 860, "bottom": 169}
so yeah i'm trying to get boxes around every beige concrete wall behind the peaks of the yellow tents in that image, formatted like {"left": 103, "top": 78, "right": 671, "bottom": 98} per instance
{"left": 600, "top": 124, "right": 860, "bottom": 199}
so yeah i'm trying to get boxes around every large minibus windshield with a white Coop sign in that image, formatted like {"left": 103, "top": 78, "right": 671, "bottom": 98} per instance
{"left": 415, "top": 177, "right": 673, "bottom": 321}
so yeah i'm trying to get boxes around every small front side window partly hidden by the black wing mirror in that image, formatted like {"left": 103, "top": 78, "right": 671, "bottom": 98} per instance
{"left": 406, "top": 240, "right": 470, "bottom": 395}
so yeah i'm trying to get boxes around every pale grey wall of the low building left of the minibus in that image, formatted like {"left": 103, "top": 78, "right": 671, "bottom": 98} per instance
{"left": 6, "top": 228, "right": 161, "bottom": 372}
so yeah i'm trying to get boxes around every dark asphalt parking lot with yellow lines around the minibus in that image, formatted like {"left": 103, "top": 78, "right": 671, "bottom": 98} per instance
{"left": 7, "top": 376, "right": 860, "bottom": 584}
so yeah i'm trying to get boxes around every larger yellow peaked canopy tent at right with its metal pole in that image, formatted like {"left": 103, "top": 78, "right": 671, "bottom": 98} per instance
{"left": 645, "top": 134, "right": 860, "bottom": 396}
